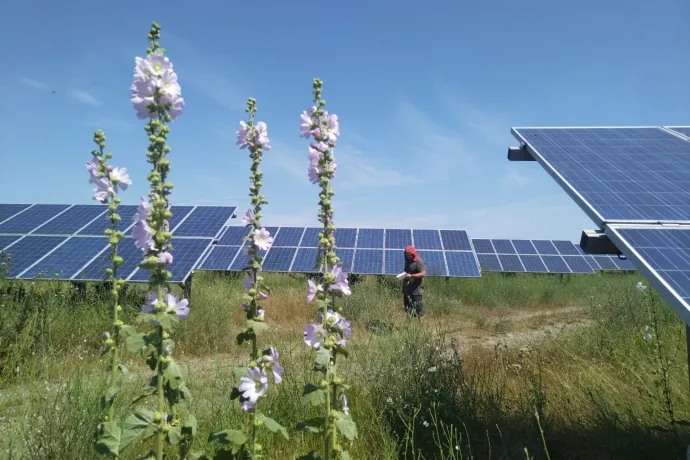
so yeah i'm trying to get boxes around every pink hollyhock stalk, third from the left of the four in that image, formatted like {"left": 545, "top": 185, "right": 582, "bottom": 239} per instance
{"left": 209, "top": 98, "right": 288, "bottom": 458}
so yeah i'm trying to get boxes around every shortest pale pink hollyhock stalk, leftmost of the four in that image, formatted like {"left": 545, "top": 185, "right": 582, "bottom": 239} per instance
{"left": 86, "top": 130, "right": 133, "bottom": 458}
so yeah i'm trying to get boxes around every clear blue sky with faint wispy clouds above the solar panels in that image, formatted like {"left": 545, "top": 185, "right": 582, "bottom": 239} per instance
{"left": 0, "top": 0, "right": 690, "bottom": 241}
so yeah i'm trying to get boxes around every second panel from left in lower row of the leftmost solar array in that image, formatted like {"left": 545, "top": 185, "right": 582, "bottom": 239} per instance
{"left": 21, "top": 236, "right": 108, "bottom": 280}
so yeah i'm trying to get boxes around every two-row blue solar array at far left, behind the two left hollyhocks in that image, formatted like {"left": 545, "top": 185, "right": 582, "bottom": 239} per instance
{"left": 0, "top": 204, "right": 236, "bottom": 282}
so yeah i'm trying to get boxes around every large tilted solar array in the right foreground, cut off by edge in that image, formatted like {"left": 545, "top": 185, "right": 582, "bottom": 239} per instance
{"left": 512, "top": 126, "right": 690, "bottom": 325}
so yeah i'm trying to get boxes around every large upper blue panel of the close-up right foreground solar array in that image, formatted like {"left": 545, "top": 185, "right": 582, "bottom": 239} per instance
{"left": 513, "top": 127, "right": 690, "bottom": 225}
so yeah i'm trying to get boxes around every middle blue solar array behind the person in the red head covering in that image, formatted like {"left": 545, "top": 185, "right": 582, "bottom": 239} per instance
{"left": 198, "top": 226, "right": 481, "bottom": 278}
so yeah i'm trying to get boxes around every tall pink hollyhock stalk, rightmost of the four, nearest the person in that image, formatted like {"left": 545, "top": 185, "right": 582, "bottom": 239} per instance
{"left": 297, "top": 78, "right": 357, "bottom": 460}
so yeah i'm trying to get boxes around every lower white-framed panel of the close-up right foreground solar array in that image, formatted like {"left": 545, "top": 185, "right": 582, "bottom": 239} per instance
{"left": 605, "top": 224, "right": 690, "bottom": 323}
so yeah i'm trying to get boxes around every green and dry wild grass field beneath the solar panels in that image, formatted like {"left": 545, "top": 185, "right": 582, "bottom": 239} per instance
{"left": 0, "top": 273, "right": 690, "bottom": 460}
